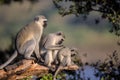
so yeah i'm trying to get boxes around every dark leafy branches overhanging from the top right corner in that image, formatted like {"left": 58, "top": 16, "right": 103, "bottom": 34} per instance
{"left": 53, "top": 0, "right": 120, "bottom": 36}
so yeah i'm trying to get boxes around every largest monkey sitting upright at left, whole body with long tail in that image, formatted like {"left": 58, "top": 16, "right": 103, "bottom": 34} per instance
{"left": 0, "top": 15, "right": 47, "bottom": 69}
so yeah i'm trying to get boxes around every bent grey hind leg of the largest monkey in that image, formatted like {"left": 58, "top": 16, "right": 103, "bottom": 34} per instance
{"left": 24, "top": 40, "right": 36, "bottom": 60}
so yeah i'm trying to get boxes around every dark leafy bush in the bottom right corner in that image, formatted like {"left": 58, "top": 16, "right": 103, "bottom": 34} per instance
{"left": 94, "top": 50, "right": 120, "bottom": 80}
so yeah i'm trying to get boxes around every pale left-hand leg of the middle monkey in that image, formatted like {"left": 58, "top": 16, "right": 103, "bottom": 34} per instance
{"left": 45, "top": 50, "right": 53, "bottom": 67}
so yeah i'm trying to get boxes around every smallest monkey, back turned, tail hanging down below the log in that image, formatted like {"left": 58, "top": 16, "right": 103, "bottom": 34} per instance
{"left": 54, "top": 47, "right": 78, "bottom": 80}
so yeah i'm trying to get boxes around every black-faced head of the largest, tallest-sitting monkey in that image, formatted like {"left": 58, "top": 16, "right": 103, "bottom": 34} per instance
{"left": 34, "top": 15, "right": 47, "bottom": 28}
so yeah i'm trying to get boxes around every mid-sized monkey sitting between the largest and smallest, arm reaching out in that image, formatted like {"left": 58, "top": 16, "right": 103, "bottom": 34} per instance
{"left": 43, "top": 31, "right": 65, "bottom": 67}
